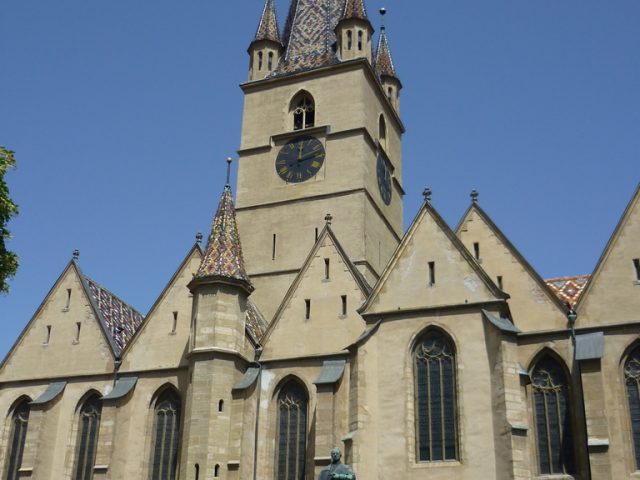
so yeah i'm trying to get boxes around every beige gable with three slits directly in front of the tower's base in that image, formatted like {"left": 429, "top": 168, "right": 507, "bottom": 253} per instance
{"left": 262, "top": 227, "right": 366, "bottom": 358}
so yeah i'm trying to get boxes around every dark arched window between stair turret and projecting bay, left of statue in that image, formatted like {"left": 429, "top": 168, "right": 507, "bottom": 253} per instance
{"left": 276, "top": 380, "right": 309, "bottom": 480}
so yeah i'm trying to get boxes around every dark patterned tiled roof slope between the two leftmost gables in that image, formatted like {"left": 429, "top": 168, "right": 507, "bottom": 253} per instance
{"left": 84, "top": 276, "right": 144, "bottom": 351}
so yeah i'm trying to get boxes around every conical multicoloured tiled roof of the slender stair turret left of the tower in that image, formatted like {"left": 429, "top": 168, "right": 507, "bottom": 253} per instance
{"left": 196, "top": 185, "right": 251, "bottom": 285}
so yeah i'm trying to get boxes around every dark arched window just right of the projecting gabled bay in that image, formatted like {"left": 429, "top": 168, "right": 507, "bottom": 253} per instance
{"left": 531, "top": 355, "right": 574, "bottom": 475}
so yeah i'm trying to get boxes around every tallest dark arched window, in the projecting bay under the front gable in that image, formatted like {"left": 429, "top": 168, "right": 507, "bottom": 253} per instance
{"left": 413, "top": 330, "right": 459, "bottom": 462}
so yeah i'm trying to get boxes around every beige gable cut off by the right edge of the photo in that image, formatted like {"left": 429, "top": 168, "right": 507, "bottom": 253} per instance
{"left": 577, "top": 186, "right": 640, "bottom": 325}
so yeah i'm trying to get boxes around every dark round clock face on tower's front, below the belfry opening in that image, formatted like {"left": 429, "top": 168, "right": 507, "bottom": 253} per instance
{"left": 276, "top": 135, "right": 325, "bottom": 183}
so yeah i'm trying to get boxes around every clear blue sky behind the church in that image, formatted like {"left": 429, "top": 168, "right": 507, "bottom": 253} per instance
{"left": 0, "top": 0, "right": 640, "bottom": 356}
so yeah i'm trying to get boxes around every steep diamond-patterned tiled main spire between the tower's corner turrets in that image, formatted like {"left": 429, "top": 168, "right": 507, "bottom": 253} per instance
{"left": 272, "top": 0, "right": 344, "bottom": 76}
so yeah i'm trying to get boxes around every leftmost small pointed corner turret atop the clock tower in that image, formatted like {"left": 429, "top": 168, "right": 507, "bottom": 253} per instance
{"left": 249, "top": 0, "right": 283, "bottom": 81}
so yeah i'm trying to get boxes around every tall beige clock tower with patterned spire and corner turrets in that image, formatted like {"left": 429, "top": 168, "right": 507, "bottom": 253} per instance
{"left": 236, "top": 0, "right": 404, "bottom": 320}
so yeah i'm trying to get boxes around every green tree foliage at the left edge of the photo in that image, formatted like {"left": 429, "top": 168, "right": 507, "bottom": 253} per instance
{"left": 0, "top": 145, "right": 18, "bottom": 293}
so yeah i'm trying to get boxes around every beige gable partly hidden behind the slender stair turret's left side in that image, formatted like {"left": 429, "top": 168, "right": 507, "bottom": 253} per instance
{"left": 121, "top": 246, "right": 202, "bottom": 371}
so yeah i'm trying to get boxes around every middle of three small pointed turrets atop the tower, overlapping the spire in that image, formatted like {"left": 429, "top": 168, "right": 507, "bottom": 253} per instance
{"left": 336, "top": 0, "right": 373, "bottom": 62}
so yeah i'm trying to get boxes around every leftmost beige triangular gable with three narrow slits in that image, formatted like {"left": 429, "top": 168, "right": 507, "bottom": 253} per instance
{"left": 0, "top": 262, "right": 114, "bottom": 382}
